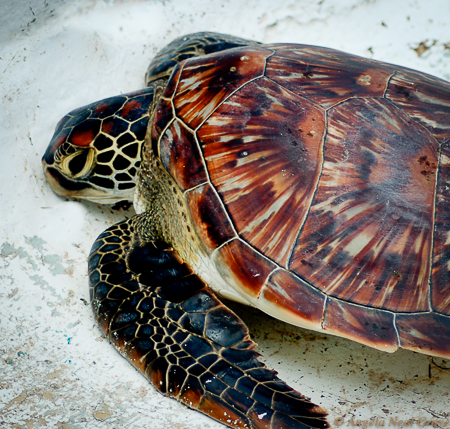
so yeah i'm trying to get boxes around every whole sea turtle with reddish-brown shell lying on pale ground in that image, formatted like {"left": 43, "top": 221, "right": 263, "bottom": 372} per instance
{"left": 43, "top": 33, "right": 450, "bottom": 429}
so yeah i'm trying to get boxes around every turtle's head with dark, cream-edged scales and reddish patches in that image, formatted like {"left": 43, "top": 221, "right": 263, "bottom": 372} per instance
{"left": 42, "top": 88, "right": 153, "bottom": 204}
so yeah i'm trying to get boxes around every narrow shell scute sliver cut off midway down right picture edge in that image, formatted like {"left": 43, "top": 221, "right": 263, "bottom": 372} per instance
{"left": 431, "top": 141, "right": 450, "bottom": 315}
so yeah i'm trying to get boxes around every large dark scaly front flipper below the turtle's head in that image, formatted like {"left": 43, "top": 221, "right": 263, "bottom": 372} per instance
{"left": 89, "top": 216, "right": 329, "bottom": 429}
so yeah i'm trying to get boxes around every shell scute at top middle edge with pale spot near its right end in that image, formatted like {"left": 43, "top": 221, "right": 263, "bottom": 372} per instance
{"left": 266, "top": 44, "right": 395, "bottom": 107}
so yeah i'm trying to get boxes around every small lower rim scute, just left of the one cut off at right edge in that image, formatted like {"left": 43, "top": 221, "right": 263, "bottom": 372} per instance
{"left": 323, "top": 298, "right": 399, "bottom": 352}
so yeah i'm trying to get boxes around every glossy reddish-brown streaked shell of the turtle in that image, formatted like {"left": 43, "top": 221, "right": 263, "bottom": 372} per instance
{"left": 152, "top": 45, "right": 450, "bottom": 357}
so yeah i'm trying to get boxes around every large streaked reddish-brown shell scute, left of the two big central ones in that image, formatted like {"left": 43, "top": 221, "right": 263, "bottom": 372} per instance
{"left": 198, "top": 79, "right": 325, "bottom": 265}
